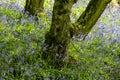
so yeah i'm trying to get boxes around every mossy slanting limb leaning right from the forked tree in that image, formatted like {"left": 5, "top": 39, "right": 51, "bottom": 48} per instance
{"left": 74, "top": 0, "right": 111, "bottom": 39}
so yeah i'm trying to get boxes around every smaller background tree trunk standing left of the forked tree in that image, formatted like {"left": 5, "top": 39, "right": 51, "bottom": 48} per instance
{"left": 25, "top": 0, "right": 44, "bottom": 15}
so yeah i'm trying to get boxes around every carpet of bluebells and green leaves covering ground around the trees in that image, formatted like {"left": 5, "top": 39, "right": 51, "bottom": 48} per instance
{"left": 0, "top": 0, "right": 120, "bottom": 80}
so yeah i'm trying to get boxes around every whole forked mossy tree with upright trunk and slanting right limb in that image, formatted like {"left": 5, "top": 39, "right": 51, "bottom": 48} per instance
{"left": 42, "top": 0, "right": 111, "bottom": 68}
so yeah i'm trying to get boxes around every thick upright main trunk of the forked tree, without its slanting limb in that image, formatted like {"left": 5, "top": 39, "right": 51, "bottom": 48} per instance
{"left": 43, "top": 0, "right": 75, "bottom": 67}
